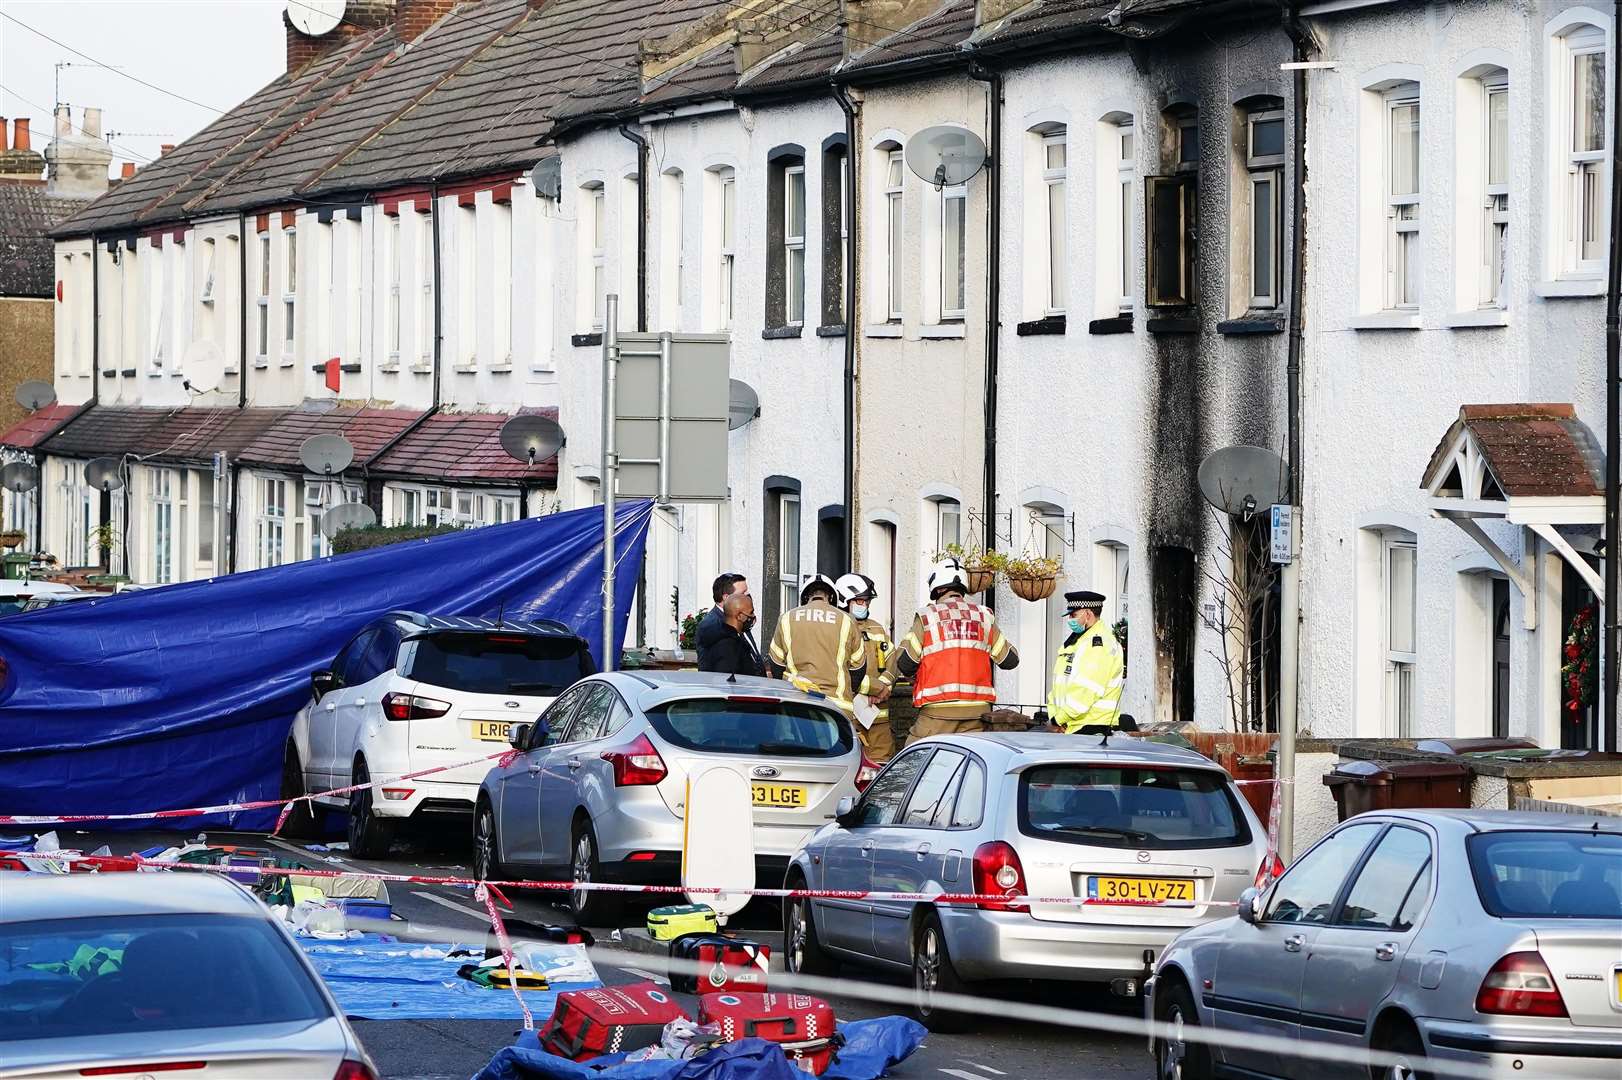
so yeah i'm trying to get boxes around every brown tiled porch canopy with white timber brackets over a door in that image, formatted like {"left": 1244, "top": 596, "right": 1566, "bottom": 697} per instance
{"left": 1421, "top": 402, "right": 1606, "bottom": 618}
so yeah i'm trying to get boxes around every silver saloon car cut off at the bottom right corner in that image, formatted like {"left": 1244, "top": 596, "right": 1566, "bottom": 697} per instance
{"left": 1150, "top": 811, "right": 1622, "bottom": 1080}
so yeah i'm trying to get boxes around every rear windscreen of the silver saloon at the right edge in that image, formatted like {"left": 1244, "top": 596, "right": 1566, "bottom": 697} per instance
{"left": 1465, "top": 830, "right": 1622, "bottom": 919}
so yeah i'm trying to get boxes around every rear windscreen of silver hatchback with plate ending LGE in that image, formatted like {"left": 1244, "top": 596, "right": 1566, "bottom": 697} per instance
{"left": 647, "top": 699, "right": 852, "bottom": 757}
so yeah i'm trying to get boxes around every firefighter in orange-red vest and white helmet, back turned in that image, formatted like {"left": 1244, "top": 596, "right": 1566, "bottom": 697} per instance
{"left": 895, "top": 559, "right": 1019, "bottom": 744}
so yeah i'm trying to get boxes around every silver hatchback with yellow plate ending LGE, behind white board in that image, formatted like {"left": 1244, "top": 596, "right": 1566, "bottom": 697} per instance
{"left": 474, "top": 671, "right": 878, "bottom": 926}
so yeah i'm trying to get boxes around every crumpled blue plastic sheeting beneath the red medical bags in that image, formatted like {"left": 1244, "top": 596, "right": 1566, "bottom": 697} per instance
{"left": 474, "top": 1017, "right": 928, "bottom": 1080}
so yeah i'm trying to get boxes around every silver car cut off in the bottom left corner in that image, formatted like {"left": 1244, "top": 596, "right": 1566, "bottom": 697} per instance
{"left": 0, "top": 872, "right": 376, "bottom": 1080}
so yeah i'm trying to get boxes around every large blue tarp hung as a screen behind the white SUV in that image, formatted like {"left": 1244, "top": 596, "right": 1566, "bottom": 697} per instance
{"left": 0, "top": 501, "right": 652, "bottom": 830}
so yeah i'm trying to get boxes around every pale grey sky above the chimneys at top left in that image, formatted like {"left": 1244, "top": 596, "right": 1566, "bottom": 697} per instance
{"left": 0, "top": 0, "right": 285, "bottom": 170}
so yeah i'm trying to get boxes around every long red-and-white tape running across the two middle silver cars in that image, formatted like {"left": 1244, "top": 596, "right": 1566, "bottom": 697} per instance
{"left": 26, "top": 851, "right": 1238, "bottom": 910}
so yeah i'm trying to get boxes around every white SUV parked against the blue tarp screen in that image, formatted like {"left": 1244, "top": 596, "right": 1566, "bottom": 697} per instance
{"left": 282, "top": 611, "right": 595, "bottom": 858}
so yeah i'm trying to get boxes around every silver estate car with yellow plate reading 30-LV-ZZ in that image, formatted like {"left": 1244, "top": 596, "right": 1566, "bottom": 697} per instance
{"left": 783, "top": 733, "right": 1267, "bottom": 1030}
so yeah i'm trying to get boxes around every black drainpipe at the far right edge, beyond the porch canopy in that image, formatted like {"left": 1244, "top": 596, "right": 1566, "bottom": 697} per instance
{"left": 1598, "top": 0, "right": 1622, "bottom": 751}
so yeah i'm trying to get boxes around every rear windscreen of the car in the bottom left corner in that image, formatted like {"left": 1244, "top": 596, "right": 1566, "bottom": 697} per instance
{"left": 0, "top": 915, "right": 333, "bottom": 1037}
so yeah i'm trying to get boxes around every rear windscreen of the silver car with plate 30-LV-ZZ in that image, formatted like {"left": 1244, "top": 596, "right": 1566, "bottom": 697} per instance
{"left": 1019, "top": 765, "right": 1251, "bottom": 848}
